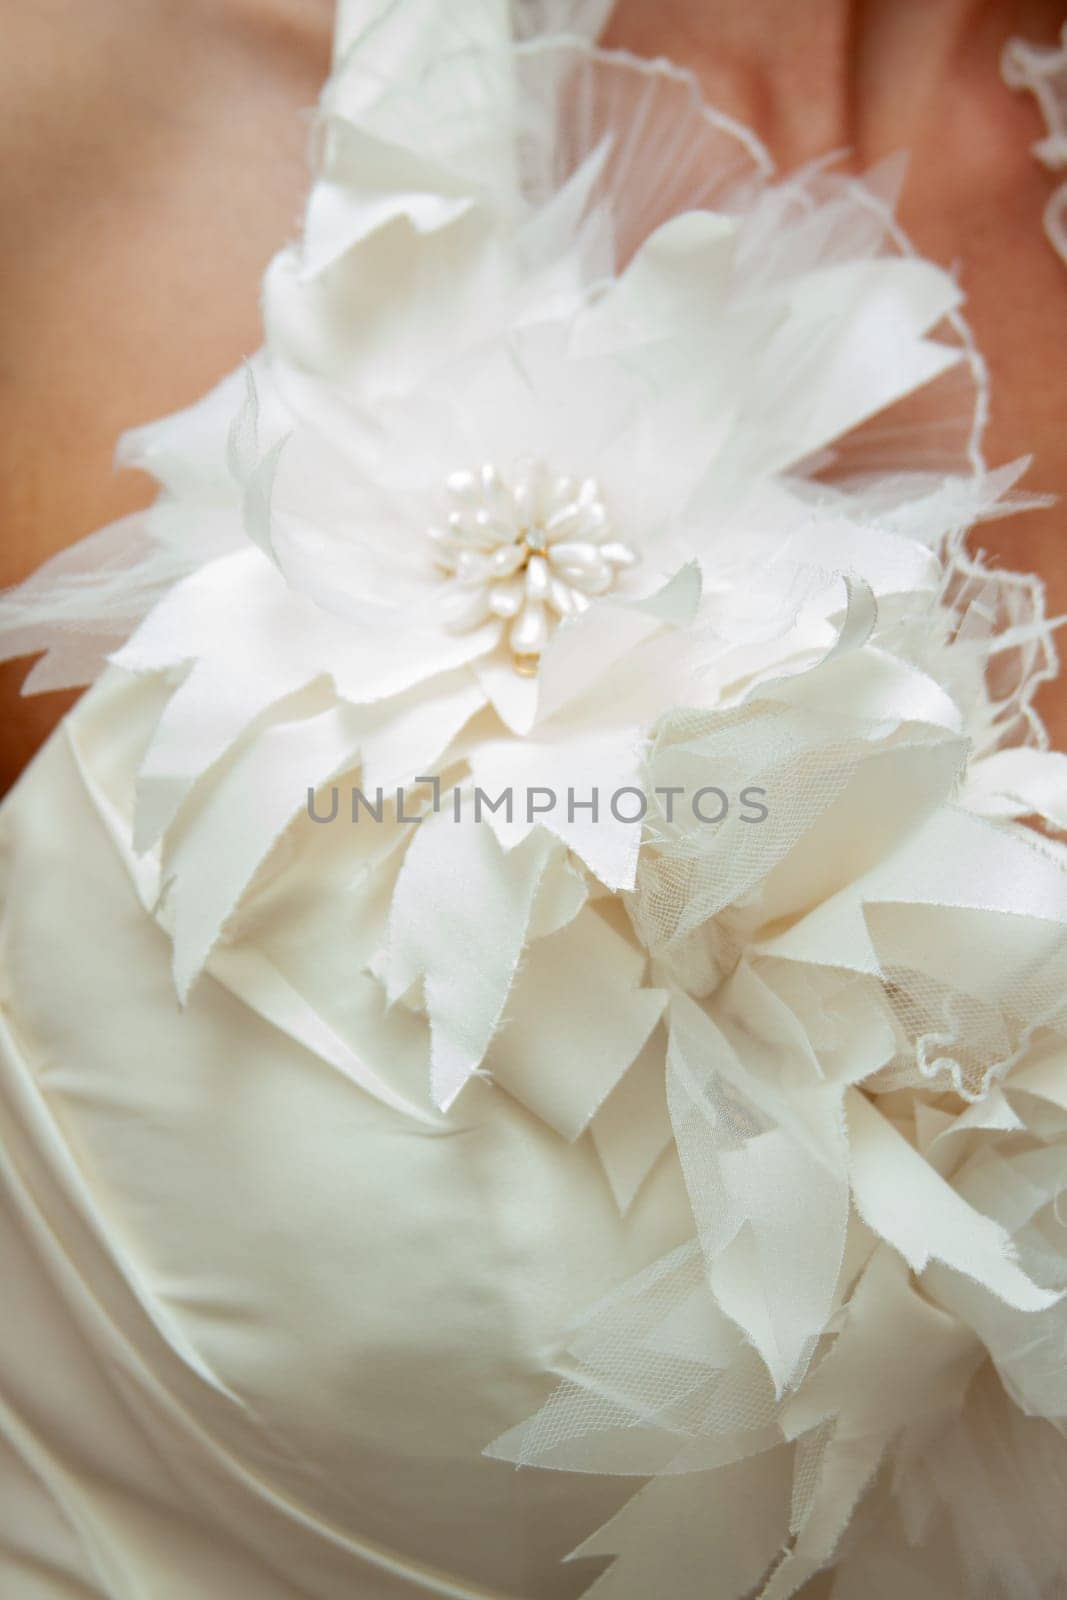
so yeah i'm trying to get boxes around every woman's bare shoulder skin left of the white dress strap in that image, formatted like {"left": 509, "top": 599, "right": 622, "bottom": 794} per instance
{"left": 0, "top": 0, "right": 331, "bottom": 790}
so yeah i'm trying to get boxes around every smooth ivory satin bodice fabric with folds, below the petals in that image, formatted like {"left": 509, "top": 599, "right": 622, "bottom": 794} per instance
{"left": 0, "top": 683, "right": 686, "bottom": 1600}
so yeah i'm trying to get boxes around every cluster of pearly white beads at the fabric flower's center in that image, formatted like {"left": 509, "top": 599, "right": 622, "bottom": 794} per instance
{"left": 430, "top": 461, "right": 637, "bottom": 675}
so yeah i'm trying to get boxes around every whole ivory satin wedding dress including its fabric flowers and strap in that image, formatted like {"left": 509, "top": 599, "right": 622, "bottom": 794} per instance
{"left": 0, "top": 0, "right": 1067, "bottom": 1600}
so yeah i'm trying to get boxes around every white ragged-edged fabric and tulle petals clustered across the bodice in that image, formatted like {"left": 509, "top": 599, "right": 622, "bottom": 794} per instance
{"left": 0, "top": 0, "right": 1067, "bottom": 1600}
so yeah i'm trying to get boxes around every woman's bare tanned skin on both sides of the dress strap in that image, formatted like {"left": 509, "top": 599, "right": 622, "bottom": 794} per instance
{"left": 0, "top": 0, "right": 1067, "bottom": 789}
